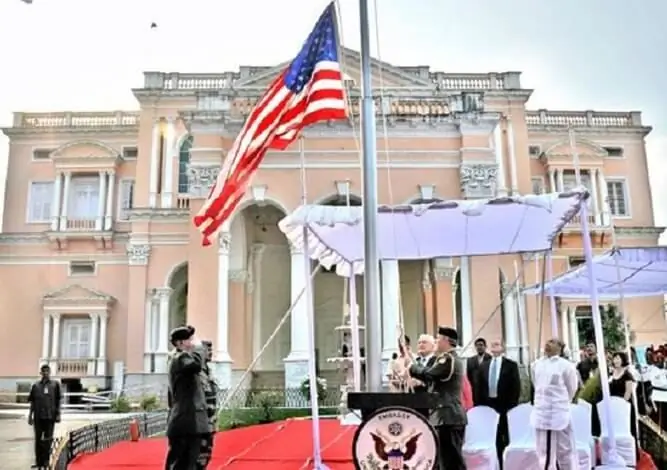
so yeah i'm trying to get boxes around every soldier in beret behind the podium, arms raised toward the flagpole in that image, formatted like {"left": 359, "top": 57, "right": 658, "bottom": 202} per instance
{"left": 410, "top": 327, "right": 468, "bottom": 470}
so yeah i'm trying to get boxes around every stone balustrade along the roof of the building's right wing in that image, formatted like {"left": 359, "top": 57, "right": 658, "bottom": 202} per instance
{"left": 526, "top": 109, "right": 642, "bottom": 127}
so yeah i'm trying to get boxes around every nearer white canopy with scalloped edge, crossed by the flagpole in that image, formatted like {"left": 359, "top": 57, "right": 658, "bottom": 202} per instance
{"left": 279, "top": 188, "right": 588, "bottom": 276}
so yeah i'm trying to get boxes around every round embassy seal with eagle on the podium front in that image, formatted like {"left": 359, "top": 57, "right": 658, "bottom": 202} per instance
{"left": 352, "top": 406, "right": 438, "bottom": 470}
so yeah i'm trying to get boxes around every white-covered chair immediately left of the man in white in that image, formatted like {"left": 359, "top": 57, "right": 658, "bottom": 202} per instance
{"left": 503, "top": 403, "right": 539, "bottom": 470}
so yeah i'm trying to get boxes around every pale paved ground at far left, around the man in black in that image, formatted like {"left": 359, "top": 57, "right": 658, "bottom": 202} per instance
{"left": 0, "top": 411, "right": 118, "bottom": 470}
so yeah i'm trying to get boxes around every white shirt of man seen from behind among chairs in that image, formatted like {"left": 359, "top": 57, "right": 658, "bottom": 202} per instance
{"left": 530, "top": 356, "right": 578, "bottom": 431}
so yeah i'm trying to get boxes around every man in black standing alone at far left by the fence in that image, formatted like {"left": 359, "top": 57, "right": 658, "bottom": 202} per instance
{"left": 28, "top": 364, "right": 62, "bottom": 470}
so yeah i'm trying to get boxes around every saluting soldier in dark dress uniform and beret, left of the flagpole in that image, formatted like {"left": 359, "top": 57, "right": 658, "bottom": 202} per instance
{"left": 166, "top": 326, "right": 210, "bottom": 470}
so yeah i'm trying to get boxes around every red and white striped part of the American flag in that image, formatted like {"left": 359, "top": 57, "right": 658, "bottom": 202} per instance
{"left": 194, "top": 61, "right": 347, "bottom": 245}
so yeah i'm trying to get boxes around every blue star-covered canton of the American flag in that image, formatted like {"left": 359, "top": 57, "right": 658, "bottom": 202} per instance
{"left": 285, "top": 3, "right": 338, "bottom": 93}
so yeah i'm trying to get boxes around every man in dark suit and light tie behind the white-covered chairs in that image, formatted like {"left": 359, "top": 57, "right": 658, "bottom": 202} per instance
{"left": 479, "top": 340, "right": 528, "bottom": 462}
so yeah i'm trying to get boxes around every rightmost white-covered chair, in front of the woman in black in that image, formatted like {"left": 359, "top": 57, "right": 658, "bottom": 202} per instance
{"left": 597, "top": 397, "right": 637, "bottom": 467}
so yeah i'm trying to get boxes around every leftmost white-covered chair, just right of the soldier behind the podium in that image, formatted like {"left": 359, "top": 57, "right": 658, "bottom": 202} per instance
{"left": 463, "top": 406, "right": 500, "bottom": 470}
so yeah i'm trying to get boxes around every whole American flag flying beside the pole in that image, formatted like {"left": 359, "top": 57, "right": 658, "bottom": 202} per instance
{"left": 194, "top": 2, "right": 347, "bottom": 246}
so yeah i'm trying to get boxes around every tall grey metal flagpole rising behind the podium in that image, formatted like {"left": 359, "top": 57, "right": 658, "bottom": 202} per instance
{"left": 359, "top": 0, "right": 382, "bottom": 392}
